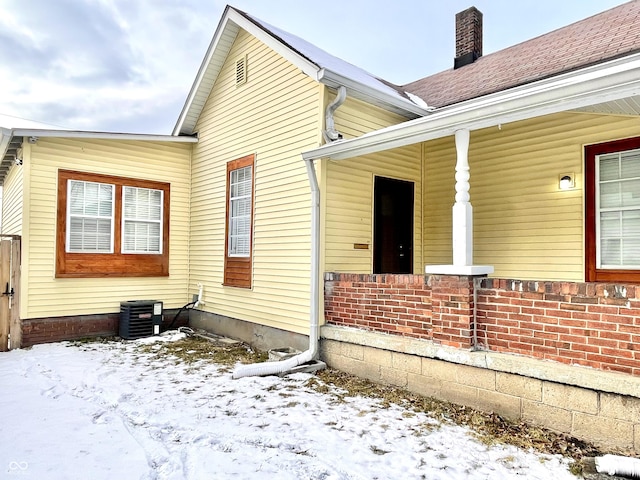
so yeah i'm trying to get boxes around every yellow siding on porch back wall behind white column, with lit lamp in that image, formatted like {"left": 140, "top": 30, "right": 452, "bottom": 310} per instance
{"left": 424, "top": 113, "right": 638, "bottom": 281}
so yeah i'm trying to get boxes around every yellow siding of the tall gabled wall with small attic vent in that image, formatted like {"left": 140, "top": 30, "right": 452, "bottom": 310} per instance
{"left": 190, "top": 26, "right": 323, "bottom": 333}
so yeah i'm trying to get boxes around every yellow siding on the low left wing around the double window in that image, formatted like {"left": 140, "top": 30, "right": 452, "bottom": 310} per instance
{"left": 21, "top": 138, "right": 191, "bottom": 318}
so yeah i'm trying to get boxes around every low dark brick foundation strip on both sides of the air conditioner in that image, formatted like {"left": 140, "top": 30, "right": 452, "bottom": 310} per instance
{"left": 21, "top": 309, "right": 189, "bottom": 347}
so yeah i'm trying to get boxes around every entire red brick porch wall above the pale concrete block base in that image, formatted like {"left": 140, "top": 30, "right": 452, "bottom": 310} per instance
{"left": 325, "top": 273, "right": 640, "bottom": 376}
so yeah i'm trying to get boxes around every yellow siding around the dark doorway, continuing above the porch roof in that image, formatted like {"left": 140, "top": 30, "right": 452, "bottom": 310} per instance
{"left": 322, "top": 95, "right": 423, "bottom": 273}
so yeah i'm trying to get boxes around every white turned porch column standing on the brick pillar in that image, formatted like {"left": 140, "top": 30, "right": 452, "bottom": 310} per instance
{"left": 453, "top": 129, "right": 473, "bottom": 267}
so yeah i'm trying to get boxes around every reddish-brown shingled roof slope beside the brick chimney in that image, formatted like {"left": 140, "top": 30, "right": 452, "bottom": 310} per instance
{"left": 402, "top": 0, "right": 640, "bottom": 107}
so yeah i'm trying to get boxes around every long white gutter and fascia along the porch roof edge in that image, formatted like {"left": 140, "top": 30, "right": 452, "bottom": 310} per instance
{"left": 302, "top": 54, "right": 640, "bottom": 160}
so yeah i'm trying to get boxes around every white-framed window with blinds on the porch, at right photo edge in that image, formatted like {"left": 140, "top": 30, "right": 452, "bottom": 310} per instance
{"left": 595, "top": 149, "right": 640, "bottom": 270}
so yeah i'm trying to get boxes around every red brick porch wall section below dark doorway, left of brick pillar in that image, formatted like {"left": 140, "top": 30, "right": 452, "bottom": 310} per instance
{"left": 324, "top": 273, "right": 433, "bottom": 340}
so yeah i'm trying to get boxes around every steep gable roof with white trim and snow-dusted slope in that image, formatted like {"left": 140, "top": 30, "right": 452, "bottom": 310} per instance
{"left": 173, "top": 5, "right": 428, "bottom": 135}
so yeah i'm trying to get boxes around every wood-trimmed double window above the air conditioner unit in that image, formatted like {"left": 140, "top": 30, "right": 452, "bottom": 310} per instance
{"left": 56, "top": 170, "right": 170, "bottom": 278}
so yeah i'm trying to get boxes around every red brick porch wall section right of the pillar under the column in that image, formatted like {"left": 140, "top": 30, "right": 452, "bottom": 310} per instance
{"left": 477, "top": 278, "right": 640, "bottom": 375}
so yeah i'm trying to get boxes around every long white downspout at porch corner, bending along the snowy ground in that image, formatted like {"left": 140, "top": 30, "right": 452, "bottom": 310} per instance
{"left": 232, "top": 160, "right": 320, "bottom": 379}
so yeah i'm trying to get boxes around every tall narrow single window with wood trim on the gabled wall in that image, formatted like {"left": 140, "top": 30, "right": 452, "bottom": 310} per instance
{"left": 224, "top": 155, "right": 254, "bottom": 288}
